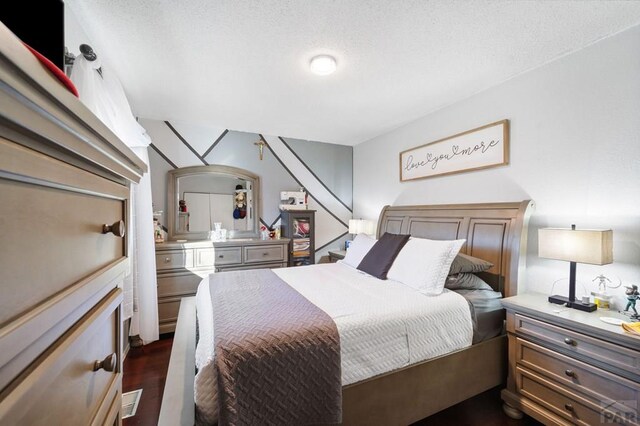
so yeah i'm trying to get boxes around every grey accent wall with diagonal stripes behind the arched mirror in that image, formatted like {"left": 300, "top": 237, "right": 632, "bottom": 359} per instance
{"left": 139, "top": 118, "right": 353, "bottom": 257}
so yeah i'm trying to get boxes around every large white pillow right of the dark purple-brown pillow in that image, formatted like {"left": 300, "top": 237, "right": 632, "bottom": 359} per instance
{"left": 387, "top": 238, "right": 465, "bottom": 295}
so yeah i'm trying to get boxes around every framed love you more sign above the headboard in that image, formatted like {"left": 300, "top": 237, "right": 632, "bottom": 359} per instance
{"left": 400, "top": 120, "right": 509, "bottom": 182}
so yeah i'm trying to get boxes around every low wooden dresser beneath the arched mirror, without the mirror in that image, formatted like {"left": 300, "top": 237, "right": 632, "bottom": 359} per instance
{"left": 156, "top": 238, "right": 289, "bottom": 333}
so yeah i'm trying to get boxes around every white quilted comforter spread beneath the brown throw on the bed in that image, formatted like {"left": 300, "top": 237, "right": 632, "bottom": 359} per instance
{"left": 195, "top": 262, "right": 473, "bottom": 423}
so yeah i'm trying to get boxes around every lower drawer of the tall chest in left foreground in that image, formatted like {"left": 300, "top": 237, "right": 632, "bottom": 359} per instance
{"left": 0, "top": 289, "right": 122, "bottom": 425}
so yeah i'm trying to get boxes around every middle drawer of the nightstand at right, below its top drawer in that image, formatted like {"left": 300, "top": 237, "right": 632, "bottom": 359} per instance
{"left": 516, "top": 338, "right": 640, "bottom": 409}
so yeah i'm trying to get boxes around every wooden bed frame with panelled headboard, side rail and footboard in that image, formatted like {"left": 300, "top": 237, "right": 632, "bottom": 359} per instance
{"left": 159, "top": 200, "right": 532, "bottom": 425}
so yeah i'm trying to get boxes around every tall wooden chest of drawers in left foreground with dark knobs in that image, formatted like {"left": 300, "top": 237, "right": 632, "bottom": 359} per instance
{"left": 0, "top": 24, "right": 146, "bottom": 425}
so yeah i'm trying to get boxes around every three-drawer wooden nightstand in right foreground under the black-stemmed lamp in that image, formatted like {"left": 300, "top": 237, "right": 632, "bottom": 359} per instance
{"left": 502, "top": 293, "right": 640, "bottom": 425}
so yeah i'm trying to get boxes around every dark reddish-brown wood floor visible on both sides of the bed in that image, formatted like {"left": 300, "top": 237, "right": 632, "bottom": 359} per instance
{"left": 122, "top": 336, "right": 540, "bottom": 426}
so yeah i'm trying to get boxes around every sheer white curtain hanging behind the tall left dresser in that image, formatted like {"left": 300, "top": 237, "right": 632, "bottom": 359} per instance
{"left": 71, "top": 55, "right": 158, "bottom": 344}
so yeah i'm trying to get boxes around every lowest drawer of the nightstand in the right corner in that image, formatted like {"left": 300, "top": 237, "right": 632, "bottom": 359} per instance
{"left": 516, "top": 368, "right": 637, "bottom": 426}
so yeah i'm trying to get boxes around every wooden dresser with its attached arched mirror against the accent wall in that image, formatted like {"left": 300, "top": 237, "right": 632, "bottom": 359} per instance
{"left": 156, "top": 164, "right": 290, "bottom": 334}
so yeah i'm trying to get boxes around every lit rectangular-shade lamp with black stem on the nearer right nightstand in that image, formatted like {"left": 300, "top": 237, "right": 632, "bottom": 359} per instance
{"left": 538, "top": 225, "right": 613, "bottom": 312}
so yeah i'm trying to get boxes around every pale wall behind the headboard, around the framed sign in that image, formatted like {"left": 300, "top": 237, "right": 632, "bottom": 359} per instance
{"left": 353, "top": 26, "right": 640, "bottom": 307}
